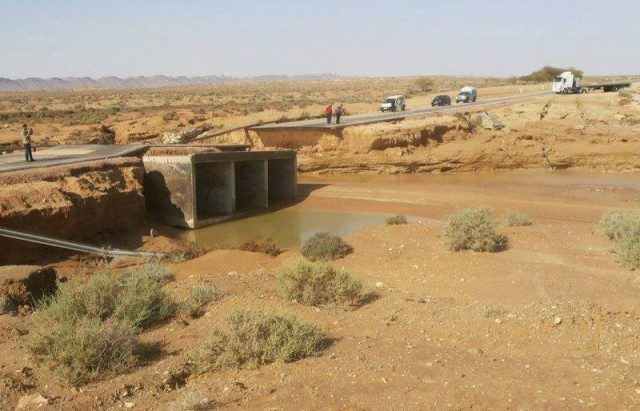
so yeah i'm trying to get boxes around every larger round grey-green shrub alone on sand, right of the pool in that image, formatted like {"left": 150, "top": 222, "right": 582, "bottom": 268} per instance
{"left": 444, "top": 208, "right": 507, "bottom": 252}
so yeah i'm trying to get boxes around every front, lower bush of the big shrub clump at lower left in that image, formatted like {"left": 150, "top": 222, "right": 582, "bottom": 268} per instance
{"left": 29, "top": 313, "right": 138, "bottom": 385}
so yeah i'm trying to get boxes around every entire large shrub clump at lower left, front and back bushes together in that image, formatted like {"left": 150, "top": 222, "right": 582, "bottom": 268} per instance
{"left": 28, "top": 266, "right": 174, "bottom": 385}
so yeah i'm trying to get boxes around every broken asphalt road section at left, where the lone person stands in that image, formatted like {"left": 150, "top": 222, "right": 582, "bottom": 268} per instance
{"left": 0, "top": 144, "right": 145, "bottom": 173}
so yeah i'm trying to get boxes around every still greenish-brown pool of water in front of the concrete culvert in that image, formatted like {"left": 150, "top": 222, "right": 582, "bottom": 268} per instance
{"left": 182, "top": 209, "right": 389, "bottom": 248}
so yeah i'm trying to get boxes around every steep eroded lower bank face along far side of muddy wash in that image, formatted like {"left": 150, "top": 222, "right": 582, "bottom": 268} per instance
{"left": 292, "top": 119, "right": 640, "bottom": 174}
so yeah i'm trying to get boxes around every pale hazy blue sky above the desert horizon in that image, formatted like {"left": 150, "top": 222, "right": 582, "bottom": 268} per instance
{"left": 0, "top": 0, "right": 640, "bottom": 79}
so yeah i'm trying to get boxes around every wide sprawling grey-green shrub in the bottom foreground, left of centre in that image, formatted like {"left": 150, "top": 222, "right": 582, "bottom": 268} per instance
{"left": 189, "top": 311, "right": 327, "bottom": 372}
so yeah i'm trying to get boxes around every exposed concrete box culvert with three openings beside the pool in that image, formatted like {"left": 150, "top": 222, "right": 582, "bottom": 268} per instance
{"left": 142, "top": 148, "right": 297, "bottom": 228}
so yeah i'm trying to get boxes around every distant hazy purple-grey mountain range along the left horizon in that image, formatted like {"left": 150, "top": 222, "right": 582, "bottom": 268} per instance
{"left": 0, "top": 74, "right": 338, "bottom": 91}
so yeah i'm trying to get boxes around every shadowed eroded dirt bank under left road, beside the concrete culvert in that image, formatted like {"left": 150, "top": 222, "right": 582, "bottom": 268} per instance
{"left": 0, "top": 158, "right": 145, "bottom": 264}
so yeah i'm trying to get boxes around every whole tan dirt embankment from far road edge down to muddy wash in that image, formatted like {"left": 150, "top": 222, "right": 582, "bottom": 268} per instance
{"left": 278, "top": 93, "right": 640, "bottom": 174}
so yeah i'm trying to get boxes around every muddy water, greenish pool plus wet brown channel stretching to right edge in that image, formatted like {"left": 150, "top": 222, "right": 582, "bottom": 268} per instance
{"left": 178, "top": 170, "right": 640, "bottom": 249}
